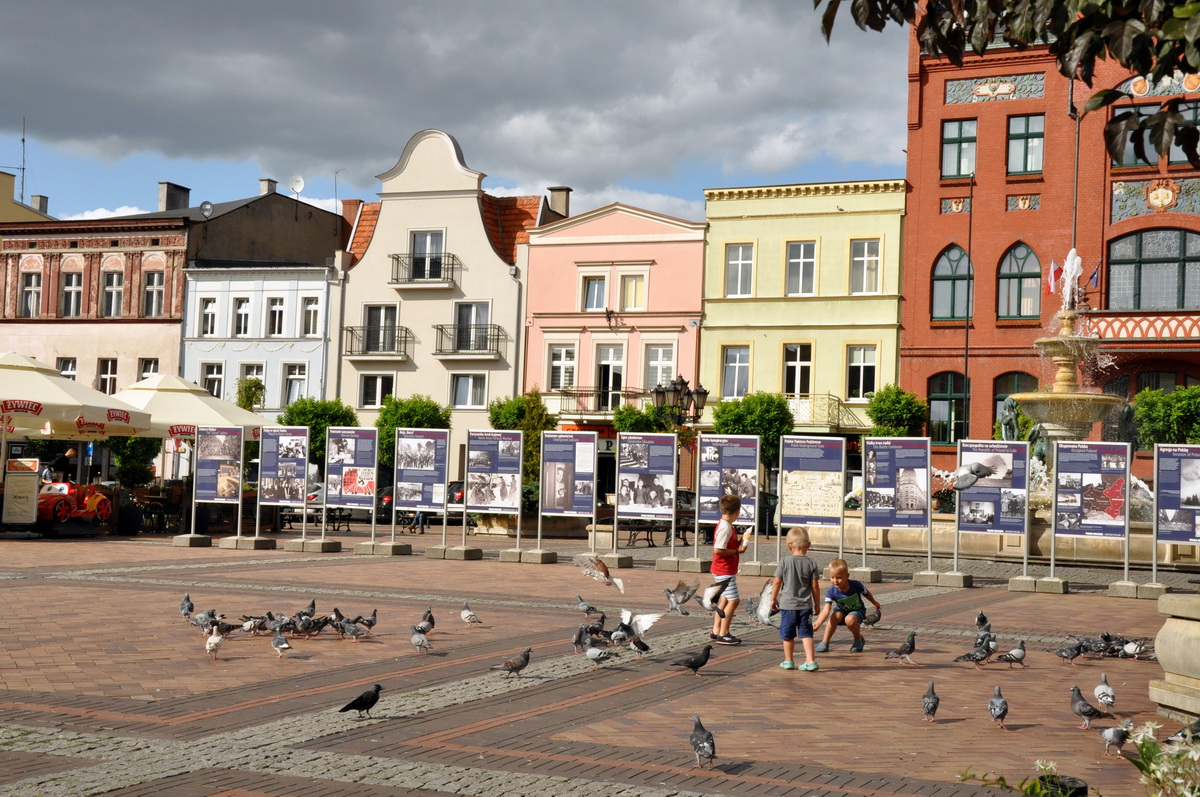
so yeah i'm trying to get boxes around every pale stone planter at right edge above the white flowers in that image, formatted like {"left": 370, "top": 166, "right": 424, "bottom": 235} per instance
{"left": 1150, "top": 593, "right": 1200, "bottom": 723}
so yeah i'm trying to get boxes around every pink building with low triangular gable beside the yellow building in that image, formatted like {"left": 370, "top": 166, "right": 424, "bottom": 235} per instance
{"left": 524, "top": 203, "right": 706, "bottom": 495}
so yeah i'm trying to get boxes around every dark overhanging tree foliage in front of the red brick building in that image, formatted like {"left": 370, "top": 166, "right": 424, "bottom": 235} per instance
{"left": 814, "top": 0, "right": 1200, "bottom": 168}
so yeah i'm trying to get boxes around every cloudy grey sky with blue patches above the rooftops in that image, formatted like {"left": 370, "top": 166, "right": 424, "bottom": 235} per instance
{"left": 0, "top": 0, "right": 907, "bottom": 221}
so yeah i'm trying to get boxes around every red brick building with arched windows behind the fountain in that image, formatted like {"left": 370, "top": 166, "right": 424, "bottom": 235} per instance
{"left": 900, "top": 34, "right": 1200, "bottom": 475}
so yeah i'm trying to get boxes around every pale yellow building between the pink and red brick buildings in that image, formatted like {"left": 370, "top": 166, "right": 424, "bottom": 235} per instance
{"left": 700, "top": 180, "right": 905, "bottom": 435}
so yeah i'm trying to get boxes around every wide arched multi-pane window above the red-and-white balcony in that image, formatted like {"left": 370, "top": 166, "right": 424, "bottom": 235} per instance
{"left": 1108, "top": 229, "right": 1200, "bottom": 310}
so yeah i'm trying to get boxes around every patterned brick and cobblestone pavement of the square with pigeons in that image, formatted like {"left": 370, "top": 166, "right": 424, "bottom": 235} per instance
{"left": 0, "top": 525, "right": 1184, "bottom": 796}
